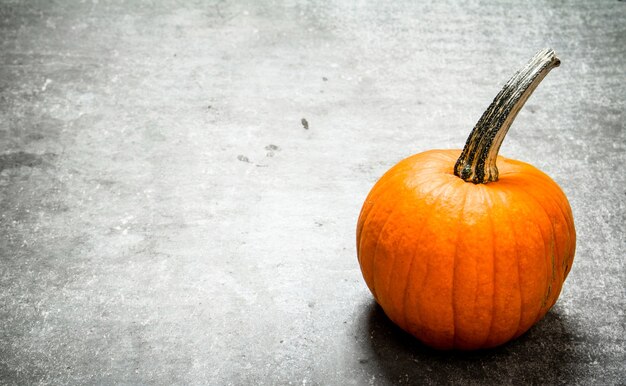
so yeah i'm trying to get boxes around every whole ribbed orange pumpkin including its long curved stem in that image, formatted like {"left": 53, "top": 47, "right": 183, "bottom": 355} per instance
{"left": 357, "top": 49, "right": 576, "bottom": 350}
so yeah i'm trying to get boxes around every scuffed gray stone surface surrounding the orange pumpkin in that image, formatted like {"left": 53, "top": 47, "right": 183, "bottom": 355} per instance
{"left": 0, "top": 0, "right": 626, "bottom": 385}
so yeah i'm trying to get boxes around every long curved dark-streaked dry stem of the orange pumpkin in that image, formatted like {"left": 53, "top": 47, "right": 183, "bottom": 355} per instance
{"left": 454, "top": 48, "right": 561, "bottom": 184}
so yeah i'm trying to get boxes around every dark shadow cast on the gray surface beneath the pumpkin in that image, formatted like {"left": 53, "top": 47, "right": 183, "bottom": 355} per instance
{"left": 357, "top": 300, "right": 584, "bottom": 384}
